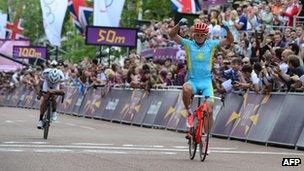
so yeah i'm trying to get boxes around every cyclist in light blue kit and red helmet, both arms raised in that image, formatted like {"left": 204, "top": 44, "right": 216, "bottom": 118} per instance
{"left": 169, "top": 18, "right": 234, "bottom": 138}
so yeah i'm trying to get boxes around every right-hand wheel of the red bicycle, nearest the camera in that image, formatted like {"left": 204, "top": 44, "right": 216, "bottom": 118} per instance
{"left": 199, "top": 111, "right": 209, "bottom": 162}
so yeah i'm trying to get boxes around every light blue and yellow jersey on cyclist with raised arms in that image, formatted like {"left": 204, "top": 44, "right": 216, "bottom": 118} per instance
{"left": 181, "top": 39, "right": 220, "bottom": 79}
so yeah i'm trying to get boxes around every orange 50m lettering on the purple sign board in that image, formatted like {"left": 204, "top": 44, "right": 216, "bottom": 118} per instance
{"left": 97, "top": 29, "right": 125, "bottom": 43}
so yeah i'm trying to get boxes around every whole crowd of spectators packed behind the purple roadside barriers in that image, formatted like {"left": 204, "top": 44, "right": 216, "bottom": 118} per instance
{"left": 0, "top": 0, "right": 304, "bottom": 93}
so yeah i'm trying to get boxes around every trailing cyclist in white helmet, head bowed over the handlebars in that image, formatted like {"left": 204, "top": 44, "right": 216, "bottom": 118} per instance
{"left": 37, "top": 68, "right": 65, "bottom": 129}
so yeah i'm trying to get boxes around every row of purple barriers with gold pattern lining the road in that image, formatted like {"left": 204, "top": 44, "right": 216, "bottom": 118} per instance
{"left": 0, "top": 85, "right": 304, "bottom": 149}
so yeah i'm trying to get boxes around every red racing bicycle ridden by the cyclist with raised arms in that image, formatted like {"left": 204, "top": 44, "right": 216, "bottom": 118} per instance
{"left": 188, "top": 91, "right": 224, "bottom": 161}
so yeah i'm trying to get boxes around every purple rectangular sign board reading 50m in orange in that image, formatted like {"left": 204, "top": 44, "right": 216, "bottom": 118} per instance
{"left": 86, "top": 26, "right": 137, "bottom": 47}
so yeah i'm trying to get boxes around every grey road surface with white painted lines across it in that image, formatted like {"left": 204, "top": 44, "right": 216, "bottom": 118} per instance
{"left": 0, "top": 107, "right": 304, "bottom": 171}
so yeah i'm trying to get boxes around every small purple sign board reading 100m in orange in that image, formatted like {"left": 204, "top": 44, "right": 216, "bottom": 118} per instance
{"left": 13, "top": 46, "right": 47, "bottom": 58}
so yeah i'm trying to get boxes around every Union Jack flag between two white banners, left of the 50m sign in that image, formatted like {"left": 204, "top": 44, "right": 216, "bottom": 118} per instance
{"left": 68, "top": 0, "right": 93, "bottom": 35}
